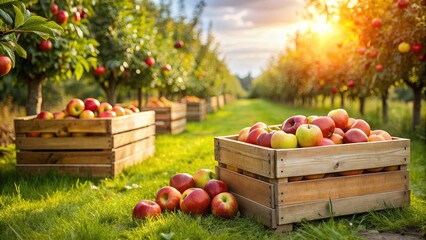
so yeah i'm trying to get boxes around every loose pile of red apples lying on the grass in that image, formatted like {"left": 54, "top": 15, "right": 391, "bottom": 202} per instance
{"left": 132, "top": 169, "right": 238, "bottom": 220}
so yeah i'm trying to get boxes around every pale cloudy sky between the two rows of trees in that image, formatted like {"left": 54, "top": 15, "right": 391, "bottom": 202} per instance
{"left": 173, "top": 0, "right": 305, "bottom": 77}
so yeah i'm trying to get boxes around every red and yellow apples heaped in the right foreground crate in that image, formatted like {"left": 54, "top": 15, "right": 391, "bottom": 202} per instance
{"left": 238, "top": 109, "right": 392, "bottom": 149}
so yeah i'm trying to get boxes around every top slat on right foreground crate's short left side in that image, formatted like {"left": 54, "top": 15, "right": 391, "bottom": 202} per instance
{"left": 215, "top": 137, "right": 275, "bottom": 178}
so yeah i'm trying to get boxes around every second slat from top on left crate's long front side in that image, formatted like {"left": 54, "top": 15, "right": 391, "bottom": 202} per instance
{"left": 16, "top": 136, "right": 112, "bottom": 150}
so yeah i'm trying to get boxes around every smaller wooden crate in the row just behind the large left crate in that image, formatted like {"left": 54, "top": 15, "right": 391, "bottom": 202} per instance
{"left": 143, "top": 103, "right": 186, "bottom": 134}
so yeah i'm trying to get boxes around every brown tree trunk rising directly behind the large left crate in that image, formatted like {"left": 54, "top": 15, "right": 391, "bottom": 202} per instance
{"left": 26, "top": 78, "right": 43, "bottom": 115}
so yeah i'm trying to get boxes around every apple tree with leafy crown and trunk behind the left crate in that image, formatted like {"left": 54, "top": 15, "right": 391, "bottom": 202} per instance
{"left": 9, "top": 0, "right": 97, "bottom": 115}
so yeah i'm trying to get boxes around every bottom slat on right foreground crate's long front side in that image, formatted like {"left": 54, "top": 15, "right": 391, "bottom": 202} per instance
{"left": 278, "top": 190, "right": 410, "bottom": 224}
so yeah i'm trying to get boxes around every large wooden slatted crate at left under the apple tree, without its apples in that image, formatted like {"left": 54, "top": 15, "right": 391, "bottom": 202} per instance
{"left": 14, "top": 111, "right": 155, "bottom": 177}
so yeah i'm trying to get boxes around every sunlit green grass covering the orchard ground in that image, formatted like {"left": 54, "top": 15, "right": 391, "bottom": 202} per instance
{"left": 0, "top": 100, "right": 426, "bottom": 239}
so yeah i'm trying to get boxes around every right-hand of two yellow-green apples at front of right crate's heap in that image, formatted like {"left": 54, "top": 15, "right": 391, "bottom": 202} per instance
{"left": 296, "top": 124, "right": 323, "bottom": 147}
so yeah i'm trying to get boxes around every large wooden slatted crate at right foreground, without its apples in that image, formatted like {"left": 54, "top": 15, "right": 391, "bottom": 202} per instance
{"left": 215, "top": 135, "right": 410, "bottom": 231}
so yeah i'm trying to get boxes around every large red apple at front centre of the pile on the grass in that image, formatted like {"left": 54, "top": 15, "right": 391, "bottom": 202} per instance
{"left": 180, "top": 188, "right": 211, "bottom": 215}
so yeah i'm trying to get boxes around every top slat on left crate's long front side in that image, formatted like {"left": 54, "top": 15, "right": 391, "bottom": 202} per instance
{"left": 14, "top": 116, "right": 111, "bottom": 133}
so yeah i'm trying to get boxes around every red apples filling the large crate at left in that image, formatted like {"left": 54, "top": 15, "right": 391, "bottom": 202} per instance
{"left": 28, "top": 98, "right": 139, "bottom": 137}
